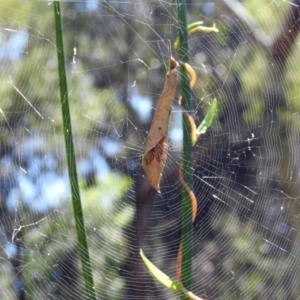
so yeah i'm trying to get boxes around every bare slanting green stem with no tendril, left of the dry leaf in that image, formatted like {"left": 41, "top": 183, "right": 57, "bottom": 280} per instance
{"left": 54, "top": 1, "right": 96, "bottom": 300}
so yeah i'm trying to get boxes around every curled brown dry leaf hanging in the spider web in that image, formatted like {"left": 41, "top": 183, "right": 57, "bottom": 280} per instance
{"left": 142, "top": 41, "right": 178, "bottom": 192}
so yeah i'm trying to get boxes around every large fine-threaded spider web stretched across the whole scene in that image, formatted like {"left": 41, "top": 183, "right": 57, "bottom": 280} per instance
{"left": 0, "top": 0, "right": 300, "bottom": 299}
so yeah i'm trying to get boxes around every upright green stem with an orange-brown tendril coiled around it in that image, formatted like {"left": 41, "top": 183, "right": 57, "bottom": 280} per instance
{"left": 177, "top": 0, "right": 193, "bottom": 290}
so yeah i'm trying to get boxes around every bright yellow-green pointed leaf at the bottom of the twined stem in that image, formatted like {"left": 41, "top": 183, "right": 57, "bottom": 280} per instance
{"left": 140, "top": 249, "right": 202, "bottom": 300}
